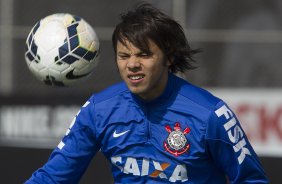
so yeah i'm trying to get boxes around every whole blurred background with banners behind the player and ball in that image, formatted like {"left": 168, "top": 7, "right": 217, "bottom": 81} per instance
{"left": 0, "top": 0, "right": 282, "bottom": 184}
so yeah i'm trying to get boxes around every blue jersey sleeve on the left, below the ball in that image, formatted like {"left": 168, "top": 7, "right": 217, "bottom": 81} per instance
{"left": 25, "top": 97, "right": 99, "bottom": 184}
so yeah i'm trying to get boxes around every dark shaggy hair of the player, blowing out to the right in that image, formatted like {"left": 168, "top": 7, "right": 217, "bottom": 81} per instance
{"left": 112, "top": 3, "right": 201, "bottom": 73}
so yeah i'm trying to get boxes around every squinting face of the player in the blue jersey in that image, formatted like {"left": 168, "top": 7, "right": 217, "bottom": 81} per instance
{"left": 117, "top": 41, "right": 170, "bottom": 100}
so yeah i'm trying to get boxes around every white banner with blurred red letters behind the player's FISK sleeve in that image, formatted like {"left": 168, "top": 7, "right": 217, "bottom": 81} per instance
{"left": 211, "top": 89, "right": 282, "bottom": 157}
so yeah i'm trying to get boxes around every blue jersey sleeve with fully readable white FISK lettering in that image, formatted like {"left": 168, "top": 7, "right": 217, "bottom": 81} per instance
{"left": 206, "top": 101, "right": 268, "bottom": 183}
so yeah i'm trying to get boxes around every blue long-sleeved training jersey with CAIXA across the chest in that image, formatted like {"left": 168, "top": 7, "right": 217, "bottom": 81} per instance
{"left": 26, "top": 74, "right": 268, "bottom": 184}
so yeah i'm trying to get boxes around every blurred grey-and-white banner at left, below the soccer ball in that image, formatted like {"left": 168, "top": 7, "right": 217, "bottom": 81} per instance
{"left": 0, "top": 105, "right": 80, "bottom": 148}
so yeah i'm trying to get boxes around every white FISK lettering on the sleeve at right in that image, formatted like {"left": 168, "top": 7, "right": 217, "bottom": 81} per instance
{"left": 215, "top": 105, "right": 251, "bottom": 164}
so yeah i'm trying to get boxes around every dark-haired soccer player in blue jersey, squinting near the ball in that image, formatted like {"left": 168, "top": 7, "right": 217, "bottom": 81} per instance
{"left": 26, "top": 4, "right": 268, "bottom": 184}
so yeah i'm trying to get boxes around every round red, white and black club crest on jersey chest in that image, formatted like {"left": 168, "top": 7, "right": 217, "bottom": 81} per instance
{"left": 164, "top": 122, "right": 191, "bottom": 156}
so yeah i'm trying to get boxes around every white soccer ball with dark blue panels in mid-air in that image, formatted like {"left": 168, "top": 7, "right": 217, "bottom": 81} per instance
{"left": 25, "top": 13, "right": 99, "bottom": 86}
